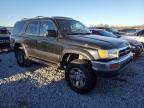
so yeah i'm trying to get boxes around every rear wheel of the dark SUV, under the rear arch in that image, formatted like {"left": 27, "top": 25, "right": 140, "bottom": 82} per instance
{"left": 15, "top": 47, "right": 30, "bottom": 67}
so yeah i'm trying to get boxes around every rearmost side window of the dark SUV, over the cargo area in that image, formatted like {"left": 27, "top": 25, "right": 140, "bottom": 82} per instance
{"left": 12, "top": 22, "right": 25, "bottom": 35}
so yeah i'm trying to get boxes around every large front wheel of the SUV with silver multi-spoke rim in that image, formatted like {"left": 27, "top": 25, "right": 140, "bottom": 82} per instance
{"left": 65, "top": 60, "right": 97, "bottom": 94}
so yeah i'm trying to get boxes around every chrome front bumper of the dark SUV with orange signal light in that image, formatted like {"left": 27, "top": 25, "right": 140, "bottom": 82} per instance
{"left": 92, "top": 52, "right": 133, "bottom": 77}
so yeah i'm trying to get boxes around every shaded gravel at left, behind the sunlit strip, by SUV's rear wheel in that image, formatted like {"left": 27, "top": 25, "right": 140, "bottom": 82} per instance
{"left": 0, "top": 52, "right": 45, "bottom": 79}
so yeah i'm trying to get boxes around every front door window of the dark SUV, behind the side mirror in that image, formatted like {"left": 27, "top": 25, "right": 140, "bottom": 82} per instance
{"left": 40, "top": 20, "right": 56, "bottom": 36}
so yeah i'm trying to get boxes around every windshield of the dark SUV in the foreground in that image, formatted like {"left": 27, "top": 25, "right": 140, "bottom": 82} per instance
{"left": 57, "top": 20, "right": 91, "bottom": 35}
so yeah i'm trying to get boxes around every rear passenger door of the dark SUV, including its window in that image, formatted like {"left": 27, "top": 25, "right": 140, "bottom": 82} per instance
{"left": 23, "top": 21, "right": 39, "bottom": 57}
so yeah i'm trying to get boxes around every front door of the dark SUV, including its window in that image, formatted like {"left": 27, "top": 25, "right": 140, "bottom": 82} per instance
{"left": 37, "top": 20, "right": 62, "bottom": 63}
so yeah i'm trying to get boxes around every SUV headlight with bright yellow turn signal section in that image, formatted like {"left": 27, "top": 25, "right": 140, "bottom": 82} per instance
{"left": 98, "top": 49, "right": 119, "bottom": 59}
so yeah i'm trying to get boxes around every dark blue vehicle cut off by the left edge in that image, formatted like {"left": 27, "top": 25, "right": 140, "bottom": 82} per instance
{"left": 0, "top": 27, "right": 10, "bottom": 50}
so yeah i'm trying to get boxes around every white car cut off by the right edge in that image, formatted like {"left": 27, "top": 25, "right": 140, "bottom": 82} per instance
{"left": 127, "top": 30, "right": 144, "bottom": 46}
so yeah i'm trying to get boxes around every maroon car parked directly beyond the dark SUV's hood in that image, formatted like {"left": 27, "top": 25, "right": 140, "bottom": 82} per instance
{"left": 91, "top": 29, "right": 143, "bottom": 57}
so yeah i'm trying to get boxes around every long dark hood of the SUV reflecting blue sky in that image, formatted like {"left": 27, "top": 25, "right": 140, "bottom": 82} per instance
{"left": 67, "top": 35, "right": 128, "bottom": 49}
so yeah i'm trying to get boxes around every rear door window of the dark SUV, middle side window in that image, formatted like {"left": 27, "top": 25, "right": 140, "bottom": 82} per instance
{"left": 26, "top": 21, "right": 38, "bottom": 35}
